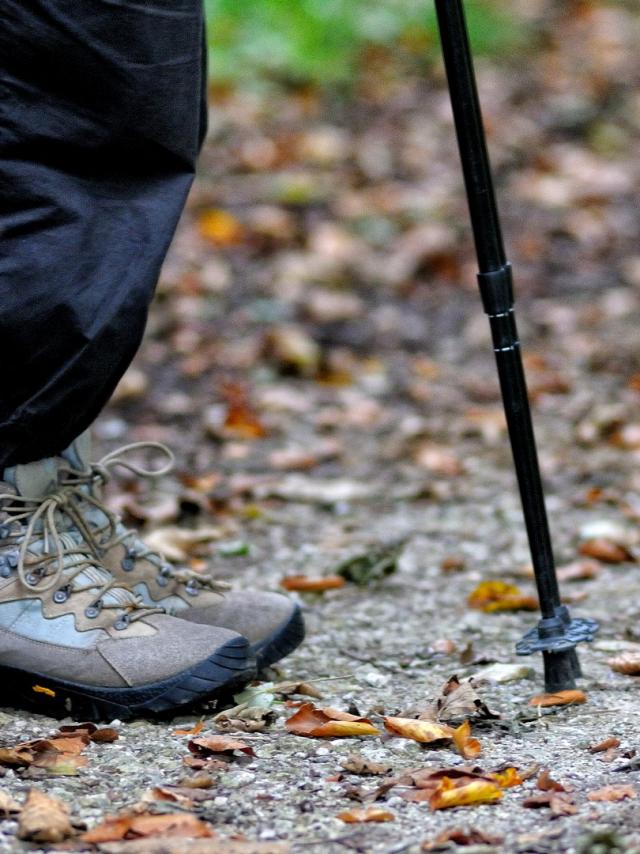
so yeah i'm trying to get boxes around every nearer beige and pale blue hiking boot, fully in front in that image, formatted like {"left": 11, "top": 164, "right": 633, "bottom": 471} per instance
{"left": 0, "top": 459, "right": 255, "bottom": 720}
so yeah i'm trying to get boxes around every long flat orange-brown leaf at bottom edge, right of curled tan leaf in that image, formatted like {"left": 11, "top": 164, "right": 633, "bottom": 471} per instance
{"left": 80, "top": 813, "right": 215, "bottom": 844}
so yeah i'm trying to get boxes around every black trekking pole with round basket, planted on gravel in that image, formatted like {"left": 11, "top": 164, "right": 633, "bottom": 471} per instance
{"left": 435, "top": 0, "right": 598, "bottom": 692}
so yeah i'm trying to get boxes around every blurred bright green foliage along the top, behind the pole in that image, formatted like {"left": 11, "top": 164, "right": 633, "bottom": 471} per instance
{"left": 205, "top": 0, "right": 523, "bottom": 85}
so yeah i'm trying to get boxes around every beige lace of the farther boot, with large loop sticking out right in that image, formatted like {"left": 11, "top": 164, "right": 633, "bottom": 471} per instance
{"left": 60, "top": 442, "right": 230, "bottom": 596}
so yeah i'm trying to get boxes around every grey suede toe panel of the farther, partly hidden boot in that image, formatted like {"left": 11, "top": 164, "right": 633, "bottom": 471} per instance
{"left": 175, "top": 590, "right": 296, "bottom": 644}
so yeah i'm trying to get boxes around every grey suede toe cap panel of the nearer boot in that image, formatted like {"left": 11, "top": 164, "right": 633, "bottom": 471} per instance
{"left": 98, "top": 615, "right": 244, "bottom": 685}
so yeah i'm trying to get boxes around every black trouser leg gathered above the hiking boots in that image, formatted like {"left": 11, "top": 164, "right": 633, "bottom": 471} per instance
{"left": 0, "top": 0, "right": 206, "bottom": 470}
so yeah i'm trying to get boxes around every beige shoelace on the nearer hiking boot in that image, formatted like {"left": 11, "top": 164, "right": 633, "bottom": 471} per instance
{"left": 0, "top": 489, "right": 162, "bottom": 630}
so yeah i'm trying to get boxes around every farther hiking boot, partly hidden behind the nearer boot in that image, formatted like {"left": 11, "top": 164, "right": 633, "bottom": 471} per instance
{"left": 62, "top": 433, "right": 304, "bottom": 669}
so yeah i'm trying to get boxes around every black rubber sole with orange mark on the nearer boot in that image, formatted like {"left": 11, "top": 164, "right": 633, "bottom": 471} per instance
{"left": 0, "top": 637, "right": 256, "bottom": 721}
